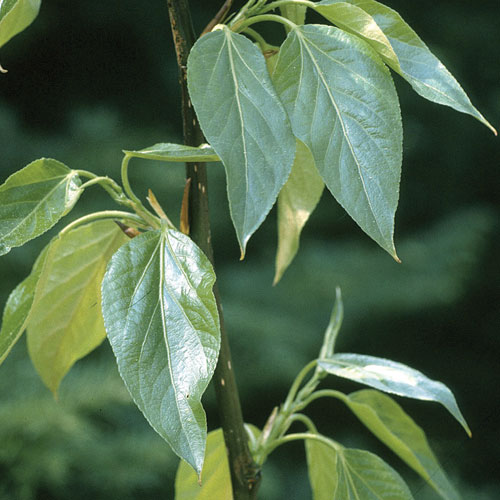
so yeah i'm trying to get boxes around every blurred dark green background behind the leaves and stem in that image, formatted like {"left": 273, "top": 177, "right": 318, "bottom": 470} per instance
{"left": 0, "top": 0, "right": 500, "bottom": 500}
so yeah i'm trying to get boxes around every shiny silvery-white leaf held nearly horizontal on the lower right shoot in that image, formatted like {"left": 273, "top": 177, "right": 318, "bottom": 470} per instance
{"left": 318, "top": 353, "right": 471, "bottom": 436}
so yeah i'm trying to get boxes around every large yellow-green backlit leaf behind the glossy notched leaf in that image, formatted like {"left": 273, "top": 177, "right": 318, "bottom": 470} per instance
{"left": 27, "top": 221, "right": 128, "bottom": 395}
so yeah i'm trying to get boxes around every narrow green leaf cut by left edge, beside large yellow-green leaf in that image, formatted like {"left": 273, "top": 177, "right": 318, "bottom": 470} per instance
{"left": 0, "top": 247, "right": 48, "bottom": 363}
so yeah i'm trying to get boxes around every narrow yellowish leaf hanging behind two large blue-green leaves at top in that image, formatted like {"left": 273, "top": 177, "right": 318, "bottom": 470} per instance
{"left": 274, "top": 140, "right": 325, "bottom": 284}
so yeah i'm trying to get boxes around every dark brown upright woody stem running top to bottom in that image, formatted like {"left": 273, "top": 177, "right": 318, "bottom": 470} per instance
{"left": 167, "top": 0, "right": 260, "bottom": 500}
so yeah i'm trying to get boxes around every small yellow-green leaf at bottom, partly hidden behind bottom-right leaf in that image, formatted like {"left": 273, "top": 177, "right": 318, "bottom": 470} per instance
{"left": 305, "top": 439, "right": 338, "bottom": 500}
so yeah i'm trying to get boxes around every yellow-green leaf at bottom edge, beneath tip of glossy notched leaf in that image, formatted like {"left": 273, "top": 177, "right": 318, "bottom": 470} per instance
{"left": 175, "top": 425, "right": 260, "bottom": 500}
